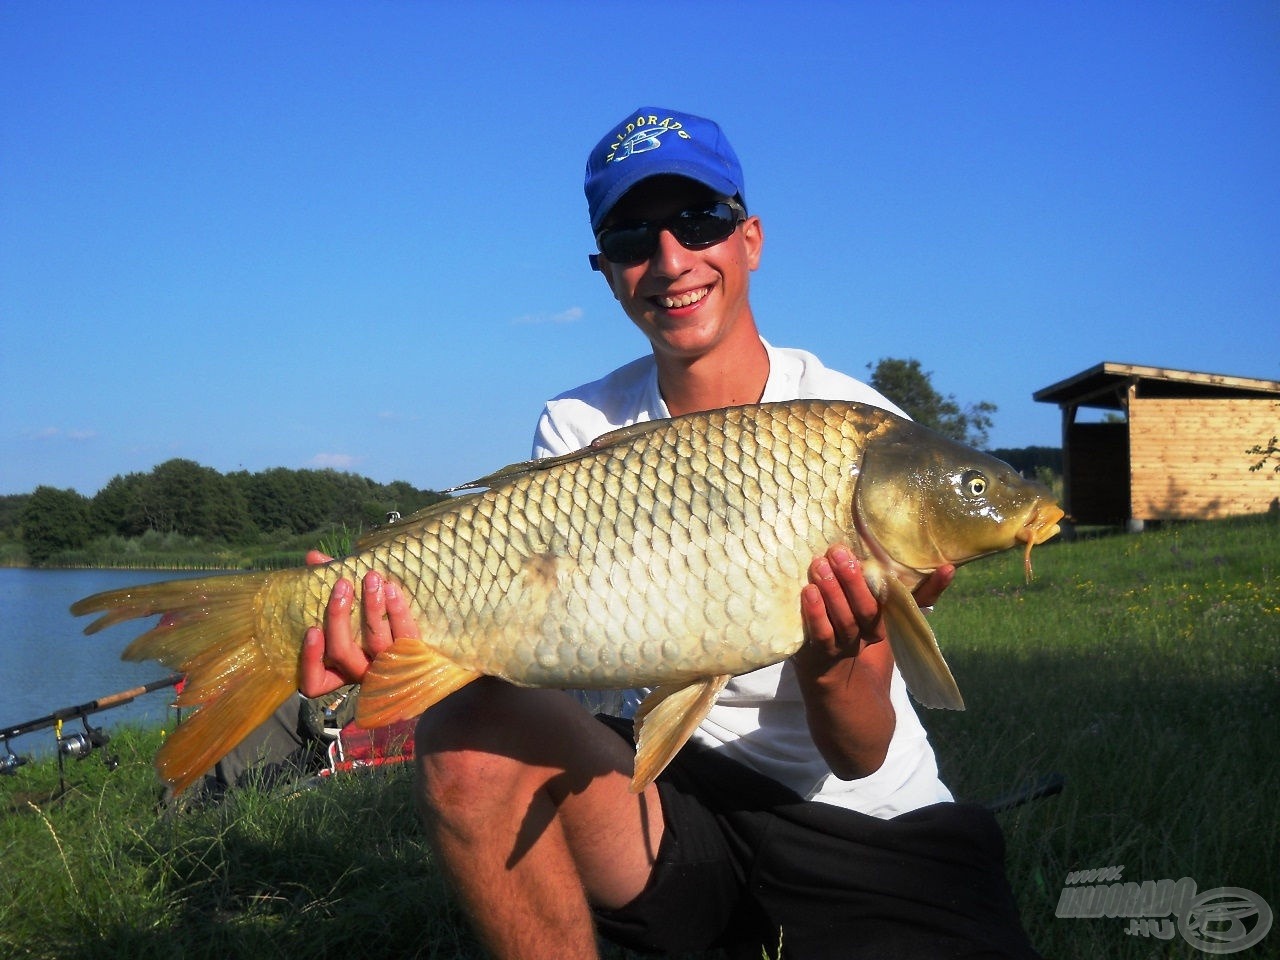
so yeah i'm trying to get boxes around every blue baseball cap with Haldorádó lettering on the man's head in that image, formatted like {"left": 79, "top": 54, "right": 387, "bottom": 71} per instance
{"left": 584, "top": 106, "right": 746, "bottom": 232}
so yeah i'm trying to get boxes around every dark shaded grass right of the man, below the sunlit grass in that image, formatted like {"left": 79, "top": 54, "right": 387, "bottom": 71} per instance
{"left": 920, "top": 646, "right": 1280, "bottom": 959}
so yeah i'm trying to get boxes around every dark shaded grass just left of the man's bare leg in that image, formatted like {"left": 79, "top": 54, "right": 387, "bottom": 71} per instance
{"left": 55, "top": 776, "right": 484, "bottom": 960}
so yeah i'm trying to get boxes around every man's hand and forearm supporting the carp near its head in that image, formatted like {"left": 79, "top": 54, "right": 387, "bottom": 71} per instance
{"left": 791, "top": 545, "right": 955, "bottom": 780}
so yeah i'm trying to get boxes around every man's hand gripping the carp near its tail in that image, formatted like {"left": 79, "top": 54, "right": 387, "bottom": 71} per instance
{"left": 298, "top": 550, "right": 417, "bottom": 696}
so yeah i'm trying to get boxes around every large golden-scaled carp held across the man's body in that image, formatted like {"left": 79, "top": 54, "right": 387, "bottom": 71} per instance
{"left": 72, "top": 401, "right": 1062, "bottom": 792}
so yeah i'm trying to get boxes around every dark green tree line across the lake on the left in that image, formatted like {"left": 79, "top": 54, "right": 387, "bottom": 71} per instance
{"left": 0, "top": 460, "right": 444, "bottom": 566}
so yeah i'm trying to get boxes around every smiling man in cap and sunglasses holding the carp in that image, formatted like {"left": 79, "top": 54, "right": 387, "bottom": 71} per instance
{"left": 303, "top": 109, "right": 1034, "bottom": 957}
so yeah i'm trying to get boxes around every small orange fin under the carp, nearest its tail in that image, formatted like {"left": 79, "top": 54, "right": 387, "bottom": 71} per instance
{"left": 356, "top": 637, "right": 481, "bottom": 727}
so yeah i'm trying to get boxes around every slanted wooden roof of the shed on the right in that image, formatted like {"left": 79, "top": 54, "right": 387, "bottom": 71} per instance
{"left": 1032, "top": 362, "right": 1280, "bottom": 410}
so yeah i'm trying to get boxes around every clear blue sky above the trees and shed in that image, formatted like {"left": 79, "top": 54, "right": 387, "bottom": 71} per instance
{"left": 0, "top": 0, "right": 1280, "bottom": 495}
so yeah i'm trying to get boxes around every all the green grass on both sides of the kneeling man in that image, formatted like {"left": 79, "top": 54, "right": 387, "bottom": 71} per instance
{"left": 0, "top": 517, "right": 1280, "bottom": 960}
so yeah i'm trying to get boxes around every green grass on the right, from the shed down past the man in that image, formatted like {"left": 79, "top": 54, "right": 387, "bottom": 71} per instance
{"left": 923, "top": 516, "right": 1280, "bottom": 957}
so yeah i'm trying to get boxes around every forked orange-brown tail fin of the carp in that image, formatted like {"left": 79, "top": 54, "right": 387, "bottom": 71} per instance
{"left": 72, "top": 570, "right": 319, "bottom": 794}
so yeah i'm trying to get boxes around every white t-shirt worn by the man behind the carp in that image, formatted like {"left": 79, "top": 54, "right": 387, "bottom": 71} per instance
{"left": 534, "top": 343, "right": 951, "bottom": 818}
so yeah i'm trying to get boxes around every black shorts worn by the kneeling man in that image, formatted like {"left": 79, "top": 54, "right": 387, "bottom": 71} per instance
{"left": 595, "top": 717, "right": 1038, "bottom": 960}
